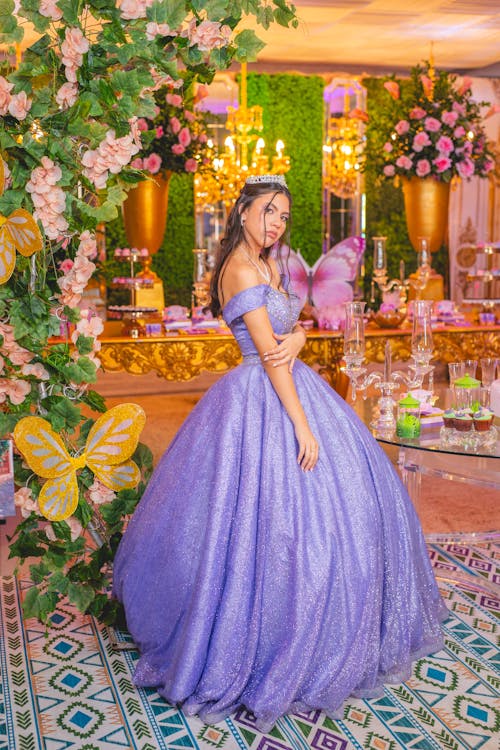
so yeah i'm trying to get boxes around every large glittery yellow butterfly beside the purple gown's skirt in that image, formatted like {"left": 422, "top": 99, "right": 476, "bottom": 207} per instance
{"left": 14, "top": 404, "right": 146, "bottom": 521}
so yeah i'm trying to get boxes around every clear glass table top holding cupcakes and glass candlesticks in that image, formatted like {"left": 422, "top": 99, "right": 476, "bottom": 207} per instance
{"left": 348, "top": 388, "right": 500, "bottom": 458}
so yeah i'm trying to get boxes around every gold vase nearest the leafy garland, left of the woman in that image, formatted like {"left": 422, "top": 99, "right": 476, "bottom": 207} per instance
{"left": 122, "top": 171, "right": 172, "bottom": 254}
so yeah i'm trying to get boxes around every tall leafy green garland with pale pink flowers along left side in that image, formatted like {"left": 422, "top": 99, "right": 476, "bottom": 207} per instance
{"left": 0, "top": 0, "right": 297, "bottom": 622}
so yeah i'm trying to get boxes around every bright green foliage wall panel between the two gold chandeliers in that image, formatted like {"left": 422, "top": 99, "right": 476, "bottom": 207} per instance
{"left": 248, "top": 73, "right": 324, "bottom": 263}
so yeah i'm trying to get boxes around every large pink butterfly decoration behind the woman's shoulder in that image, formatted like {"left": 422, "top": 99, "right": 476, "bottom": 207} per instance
{"left": 281, "top": 237, "right": 365, "bottom": 309}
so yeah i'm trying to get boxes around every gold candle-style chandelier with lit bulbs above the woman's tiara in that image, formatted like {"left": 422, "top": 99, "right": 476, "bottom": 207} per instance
{"left": 195, "top": 63, "right": 290, "bottom": 207}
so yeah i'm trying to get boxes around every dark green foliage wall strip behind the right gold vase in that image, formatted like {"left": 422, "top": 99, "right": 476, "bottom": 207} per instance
{"left": 362, "top": 78, "right": 448, "bottom": 295}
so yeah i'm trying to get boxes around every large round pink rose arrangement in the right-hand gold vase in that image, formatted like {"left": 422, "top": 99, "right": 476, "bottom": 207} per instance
{"left": 374, "top": 63, "right": 495, "bottom": 182}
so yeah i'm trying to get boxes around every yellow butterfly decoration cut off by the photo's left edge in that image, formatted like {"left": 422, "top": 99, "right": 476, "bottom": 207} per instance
{"left": 0, "top": 156, "right": 43, "bottom": 284}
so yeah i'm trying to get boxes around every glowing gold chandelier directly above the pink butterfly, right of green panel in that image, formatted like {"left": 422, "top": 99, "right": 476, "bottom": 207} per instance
{"left": 323, "top": 89, "right": 366, "bottom": 199}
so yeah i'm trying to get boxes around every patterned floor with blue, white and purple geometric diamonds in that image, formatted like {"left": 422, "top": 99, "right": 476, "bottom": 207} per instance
{"left": 0, "top": 540, "right": 500, "bottom": 750}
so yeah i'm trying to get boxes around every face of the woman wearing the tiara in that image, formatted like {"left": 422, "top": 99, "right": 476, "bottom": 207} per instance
{"left": 241, "top": 192, "right": 290, "bottom": 250}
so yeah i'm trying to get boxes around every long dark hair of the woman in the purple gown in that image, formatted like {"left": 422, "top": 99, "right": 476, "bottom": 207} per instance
{"left": 210, "top": 182, "right": 292, "bottom": 317}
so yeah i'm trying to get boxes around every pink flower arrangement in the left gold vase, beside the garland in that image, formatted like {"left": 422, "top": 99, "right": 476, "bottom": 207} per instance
{"left": 130, "top": 86, "right": 207, "bottom": 174}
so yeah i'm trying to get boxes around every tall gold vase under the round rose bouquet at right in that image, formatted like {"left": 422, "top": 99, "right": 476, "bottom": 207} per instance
{"left": 401, "top": 177, "right": 450, "bottom": 253}
